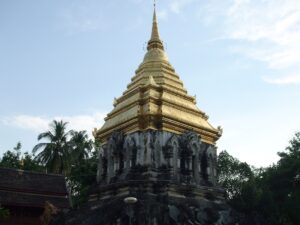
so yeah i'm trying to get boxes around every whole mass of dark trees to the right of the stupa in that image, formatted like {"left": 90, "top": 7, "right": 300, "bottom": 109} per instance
{"left": 219, "top": 133, "right": 300, "bottom": 225}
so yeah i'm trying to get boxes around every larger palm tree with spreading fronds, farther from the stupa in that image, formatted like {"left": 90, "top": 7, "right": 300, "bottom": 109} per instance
{"left": 32, "top": 120, "right": 71, "bottom": 174}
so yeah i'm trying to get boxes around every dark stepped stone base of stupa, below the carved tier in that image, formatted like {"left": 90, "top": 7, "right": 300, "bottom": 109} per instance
{"left": 54, "top": 181, "right": 235, "bottom": 225}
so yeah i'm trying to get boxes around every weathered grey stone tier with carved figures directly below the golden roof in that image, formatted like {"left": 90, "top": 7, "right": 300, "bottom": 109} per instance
{"left": 97, "top": 130, "right": 217, "bottom": 186}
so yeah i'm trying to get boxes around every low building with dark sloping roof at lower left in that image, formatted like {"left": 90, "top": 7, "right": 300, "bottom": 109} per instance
{"left": 0, "top": 168, "right": 70, "bottom": 225}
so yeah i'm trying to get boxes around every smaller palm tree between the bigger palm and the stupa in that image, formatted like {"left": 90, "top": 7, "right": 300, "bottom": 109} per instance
{"left": 70, "top": 131, "right": 93, "bottom": 163}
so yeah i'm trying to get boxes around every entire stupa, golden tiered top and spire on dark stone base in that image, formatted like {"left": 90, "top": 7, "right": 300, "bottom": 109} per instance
{"left": 53, "top": 4, "right": 237, "bottom": 225}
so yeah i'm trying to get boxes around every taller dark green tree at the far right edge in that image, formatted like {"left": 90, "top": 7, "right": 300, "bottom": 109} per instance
{"left": 260, "top": 132, "right": 300, "bottom": 225}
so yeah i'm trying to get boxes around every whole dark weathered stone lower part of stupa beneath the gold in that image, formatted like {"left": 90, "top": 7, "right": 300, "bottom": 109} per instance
{"left": 52, "top": 131, "right": 237, "bottom": 225}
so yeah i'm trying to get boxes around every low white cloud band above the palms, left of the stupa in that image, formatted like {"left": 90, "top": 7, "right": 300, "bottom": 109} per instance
{"left": 1, "top": 113, "right": 106, "bottom": 136}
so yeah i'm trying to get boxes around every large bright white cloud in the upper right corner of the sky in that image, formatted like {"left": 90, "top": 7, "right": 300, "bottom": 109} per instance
{"left": 201, "top": 0, "right": 300, "bottom": 84}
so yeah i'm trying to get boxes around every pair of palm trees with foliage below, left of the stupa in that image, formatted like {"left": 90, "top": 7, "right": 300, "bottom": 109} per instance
{"left": 33, "top": 120, "right": 97, "bottom": 207}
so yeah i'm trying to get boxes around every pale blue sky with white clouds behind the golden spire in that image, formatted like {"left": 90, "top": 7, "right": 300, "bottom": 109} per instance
{"left": 0, "top": 0, "right": 300, "bottom": 167}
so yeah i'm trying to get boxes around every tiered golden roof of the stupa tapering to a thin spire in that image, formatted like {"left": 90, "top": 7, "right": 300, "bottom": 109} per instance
{"left": 94, "top": 10, "right": 221, "bottom": 144}
